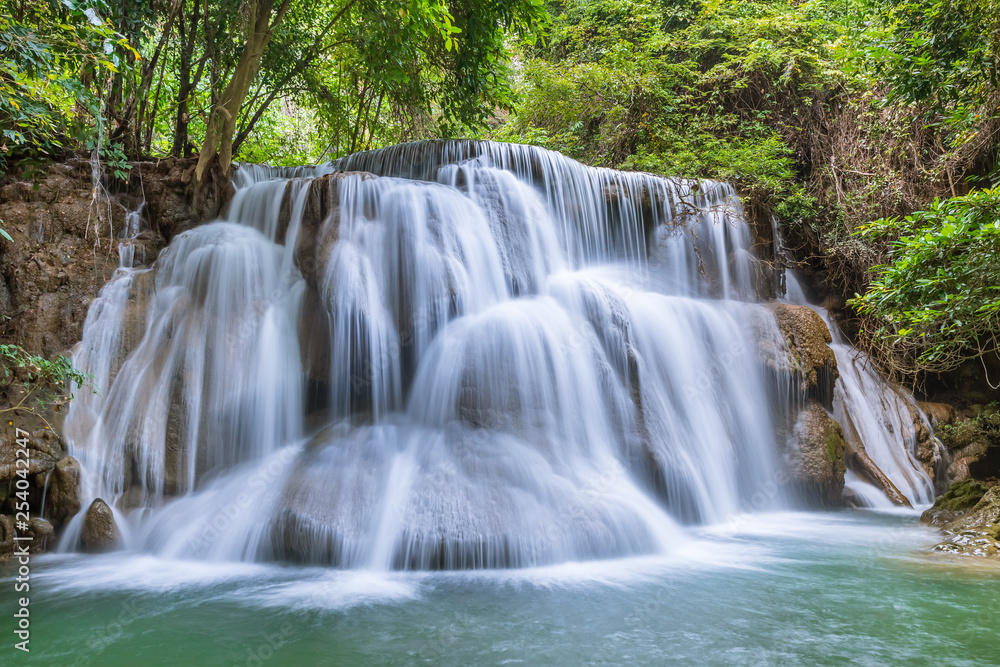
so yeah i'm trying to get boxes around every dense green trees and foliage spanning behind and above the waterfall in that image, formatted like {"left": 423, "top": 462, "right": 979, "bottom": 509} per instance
{"left": 0, "top": 0, "right": 1000, "bottom": 380}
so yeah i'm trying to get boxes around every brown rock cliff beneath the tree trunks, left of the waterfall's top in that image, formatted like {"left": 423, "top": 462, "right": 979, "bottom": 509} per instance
{"left": 0, "top": 157, "right": 232, "bottom": 357}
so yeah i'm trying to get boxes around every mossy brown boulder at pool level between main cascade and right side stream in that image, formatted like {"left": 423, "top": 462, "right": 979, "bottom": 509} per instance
{"left": 783, "top": 400, "right": 846, "bottom": 506}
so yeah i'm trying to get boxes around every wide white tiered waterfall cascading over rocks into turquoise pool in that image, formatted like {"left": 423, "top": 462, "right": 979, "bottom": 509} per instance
{"left": 63, "top": 142, "right": 926, "bottom": 569}
